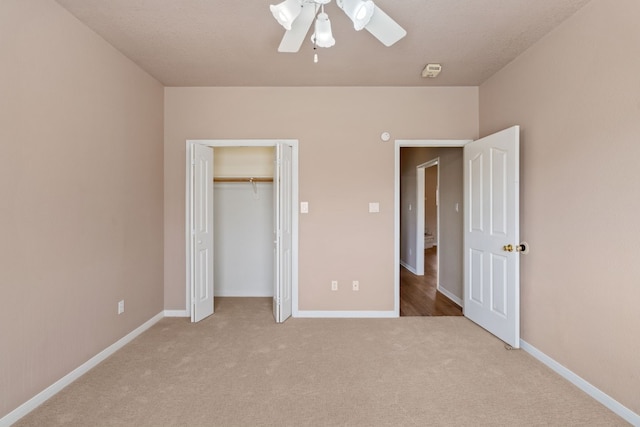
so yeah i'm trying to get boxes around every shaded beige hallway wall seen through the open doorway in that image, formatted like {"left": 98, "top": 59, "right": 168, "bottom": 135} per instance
{"left": 400, "top": 149, "right": 460, "bottom": 300}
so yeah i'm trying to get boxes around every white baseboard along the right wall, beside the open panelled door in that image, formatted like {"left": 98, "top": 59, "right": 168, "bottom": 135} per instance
{"left": 520, "top": 340, "right": 640, "bottom": 426}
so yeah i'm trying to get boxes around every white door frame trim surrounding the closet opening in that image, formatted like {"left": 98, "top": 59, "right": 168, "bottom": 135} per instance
{"left": 185, "top": 139, "right": 298, "bottom": 317}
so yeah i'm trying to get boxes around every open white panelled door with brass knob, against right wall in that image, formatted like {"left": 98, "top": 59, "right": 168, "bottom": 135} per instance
{"left": 463, "top": 126, "right": 520, "bottom": 348}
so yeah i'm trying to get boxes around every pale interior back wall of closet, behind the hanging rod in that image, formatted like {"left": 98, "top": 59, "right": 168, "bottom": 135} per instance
{"left": 213, "top": 147, "right": 274, "bottom": 297}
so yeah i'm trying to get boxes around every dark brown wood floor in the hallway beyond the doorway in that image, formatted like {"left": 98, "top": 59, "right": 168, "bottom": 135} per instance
{"left": 400, "top": 246, "right": 462, "bottom": 316}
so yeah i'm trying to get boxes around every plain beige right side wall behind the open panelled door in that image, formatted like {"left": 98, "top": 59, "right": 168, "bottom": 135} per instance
{"left": 480, "top": 0, "right": 640, "bottom": 413}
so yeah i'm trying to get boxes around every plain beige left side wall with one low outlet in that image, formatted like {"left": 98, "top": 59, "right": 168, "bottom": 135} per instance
{"left": 0, "top": 0, "right": 163, "bottom": 418}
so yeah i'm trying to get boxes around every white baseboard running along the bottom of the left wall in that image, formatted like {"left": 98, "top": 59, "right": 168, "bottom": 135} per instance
{"left": 0, "top": 312, "right": 164, "bottom": 427}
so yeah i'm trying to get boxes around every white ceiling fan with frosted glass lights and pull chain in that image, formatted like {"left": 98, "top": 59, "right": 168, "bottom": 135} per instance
{"left": 270, "top": 0, "right": 407, "bottom": 54}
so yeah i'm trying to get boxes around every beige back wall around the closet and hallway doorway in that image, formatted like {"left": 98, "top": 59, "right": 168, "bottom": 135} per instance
{"left": 165, "top": 88, "right": 478, "bottom": 310}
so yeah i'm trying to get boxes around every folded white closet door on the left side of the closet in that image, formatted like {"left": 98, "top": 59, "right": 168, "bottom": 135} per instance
{"left": 189, "top": 144, "right": 213, "bottom": 322}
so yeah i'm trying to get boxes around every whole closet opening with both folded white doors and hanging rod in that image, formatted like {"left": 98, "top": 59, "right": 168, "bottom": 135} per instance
{"left": 185, "top": 140, "right": 298, "bottom": 323}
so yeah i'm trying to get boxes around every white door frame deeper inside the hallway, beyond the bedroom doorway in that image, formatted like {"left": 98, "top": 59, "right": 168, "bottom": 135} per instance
{"left": 416, "top": 157, "right": 440, "bottom": 276}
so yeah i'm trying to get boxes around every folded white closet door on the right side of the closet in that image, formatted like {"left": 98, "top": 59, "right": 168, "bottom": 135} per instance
{"left": 273, "top": 143, "right": 293, "bottom": 323}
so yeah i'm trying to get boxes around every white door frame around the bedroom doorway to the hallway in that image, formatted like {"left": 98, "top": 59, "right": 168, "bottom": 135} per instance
{"left": 393, "top": 139, "right": 473, "bottom": 317}
